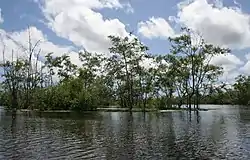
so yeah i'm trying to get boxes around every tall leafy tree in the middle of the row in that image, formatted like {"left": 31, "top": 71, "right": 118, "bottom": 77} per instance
{"left": 106, "top": 36, "right": 148, "bottom": 110}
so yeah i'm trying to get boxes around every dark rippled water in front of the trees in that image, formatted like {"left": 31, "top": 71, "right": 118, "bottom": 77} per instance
{"left": 0, "top": 106, "right": 250, "bottom": 160}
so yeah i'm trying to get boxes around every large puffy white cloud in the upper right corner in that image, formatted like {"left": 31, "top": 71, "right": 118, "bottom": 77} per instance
{"left": 171, "top": 0, "right": 250, "bottom": 49}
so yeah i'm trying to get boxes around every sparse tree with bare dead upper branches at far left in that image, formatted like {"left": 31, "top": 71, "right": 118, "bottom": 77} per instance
{"left": 1, "top": 30, "right": 40, "bottom": 110}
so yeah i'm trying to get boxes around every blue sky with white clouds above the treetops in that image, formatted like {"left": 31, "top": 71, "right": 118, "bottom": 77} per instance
{"left": 0, "top": 0, "right": 250, "bottom": 82}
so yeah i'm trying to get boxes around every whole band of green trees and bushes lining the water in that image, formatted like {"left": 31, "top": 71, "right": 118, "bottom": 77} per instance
{"left": 0, "top": 28, "right": 250, "bottom": 111}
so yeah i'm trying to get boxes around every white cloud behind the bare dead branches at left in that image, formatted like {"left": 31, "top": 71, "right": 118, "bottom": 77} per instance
{"left": 0, "top": 27, "right": 79, "bottom": 64}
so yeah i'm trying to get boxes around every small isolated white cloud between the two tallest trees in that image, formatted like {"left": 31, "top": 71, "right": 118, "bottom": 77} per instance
{"left": 138, "top": 17, "right": 175, "bottom": 39}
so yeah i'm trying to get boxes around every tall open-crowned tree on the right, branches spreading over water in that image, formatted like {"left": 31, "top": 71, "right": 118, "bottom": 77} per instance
{"left": 169, "top": 28, "right": 230, "bottom": 109}
